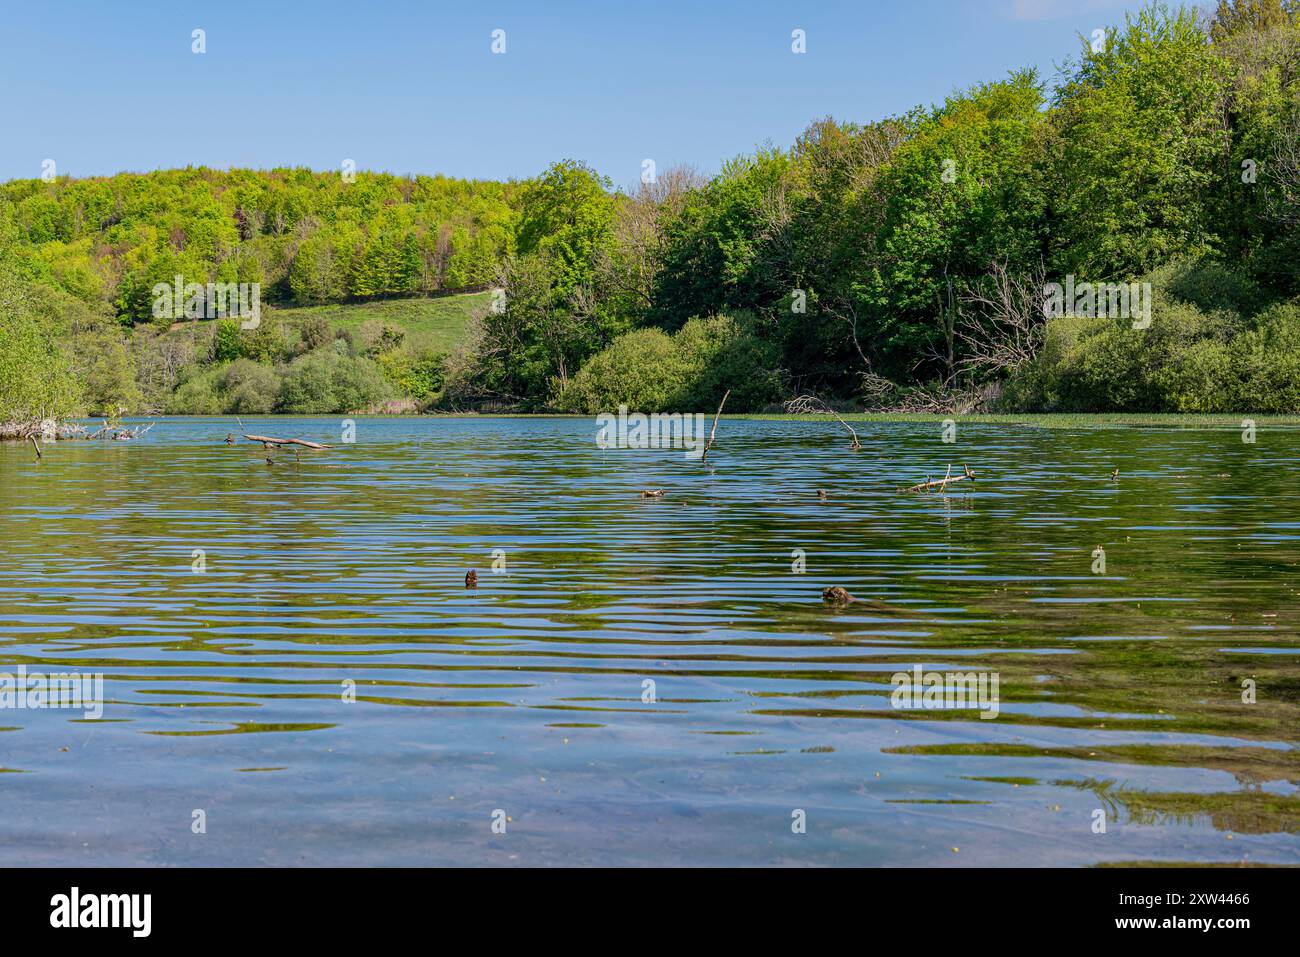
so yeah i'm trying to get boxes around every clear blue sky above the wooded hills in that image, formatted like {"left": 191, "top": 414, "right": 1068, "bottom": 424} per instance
{"left": 0, "top": 0, "right": 1138, "bottom": 185}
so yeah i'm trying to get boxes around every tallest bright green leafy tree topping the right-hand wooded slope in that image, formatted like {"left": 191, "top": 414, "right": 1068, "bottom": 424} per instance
{"left": 1048, "top": 5, "right": 1230, "bottom": 281}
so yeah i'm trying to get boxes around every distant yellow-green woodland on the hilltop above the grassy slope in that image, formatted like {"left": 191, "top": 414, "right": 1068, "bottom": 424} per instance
{"left": 0, "top": 168, "right": 519, "bottom": 315}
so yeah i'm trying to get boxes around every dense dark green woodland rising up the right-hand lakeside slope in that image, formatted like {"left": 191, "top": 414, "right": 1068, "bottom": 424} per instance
{"left": 452, "top": 0, "right": 1300, "bottom": 411}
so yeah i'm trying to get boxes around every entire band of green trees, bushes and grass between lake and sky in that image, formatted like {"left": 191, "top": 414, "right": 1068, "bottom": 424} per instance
{"left": 0, "top": 0, "right": 1300, "bottom": 439}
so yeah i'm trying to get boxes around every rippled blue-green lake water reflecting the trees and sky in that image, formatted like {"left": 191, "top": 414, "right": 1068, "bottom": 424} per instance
{"left": 0, "top": 417, "right": 1300, "bottom": 866}
